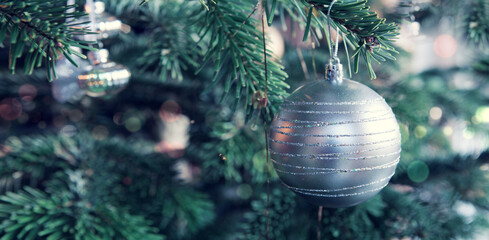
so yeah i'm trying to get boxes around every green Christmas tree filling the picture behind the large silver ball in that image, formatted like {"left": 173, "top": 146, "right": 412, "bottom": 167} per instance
{"left": 0, "top": 0, "right": 489, "bottom": 240}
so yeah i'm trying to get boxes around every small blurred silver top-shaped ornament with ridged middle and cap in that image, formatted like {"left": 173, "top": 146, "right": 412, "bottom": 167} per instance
{"left": 78, "top": 49, "right": 131, "bottom": 97}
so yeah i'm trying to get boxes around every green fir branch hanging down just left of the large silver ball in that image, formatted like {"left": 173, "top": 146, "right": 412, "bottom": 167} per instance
{"left": 199, "top": 0, "right": 288, "bottom": 117}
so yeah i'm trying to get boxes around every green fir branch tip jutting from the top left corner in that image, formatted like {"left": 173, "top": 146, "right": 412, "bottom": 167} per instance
{"left": 0, "top": 0, "right": 96, "bottom": 80}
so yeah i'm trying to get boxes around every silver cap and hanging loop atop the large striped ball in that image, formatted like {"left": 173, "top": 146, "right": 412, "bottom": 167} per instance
{"left": 326, "top": 0, "right": 343, "bottom": 83}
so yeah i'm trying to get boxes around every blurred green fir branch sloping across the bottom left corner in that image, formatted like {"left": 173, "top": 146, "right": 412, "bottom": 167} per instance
{"left": 0, "top": 187, "right": 164, "bottom": 240}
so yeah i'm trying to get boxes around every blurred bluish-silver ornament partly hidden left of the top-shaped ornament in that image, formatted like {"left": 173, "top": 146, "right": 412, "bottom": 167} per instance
{"left": 51, "top": 49, "right": 88, "bottom": 103}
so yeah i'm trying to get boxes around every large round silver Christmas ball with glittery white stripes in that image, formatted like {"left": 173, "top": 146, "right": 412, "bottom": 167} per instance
{"left": 269, "top": 79, "right": 401, "bottom": 208}
